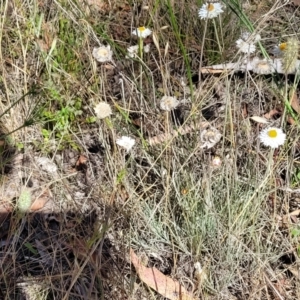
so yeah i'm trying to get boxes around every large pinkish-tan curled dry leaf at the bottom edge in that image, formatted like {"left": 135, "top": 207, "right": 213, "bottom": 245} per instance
{"left": 130, "top": 249, "right": 195, "bottom": 300}
